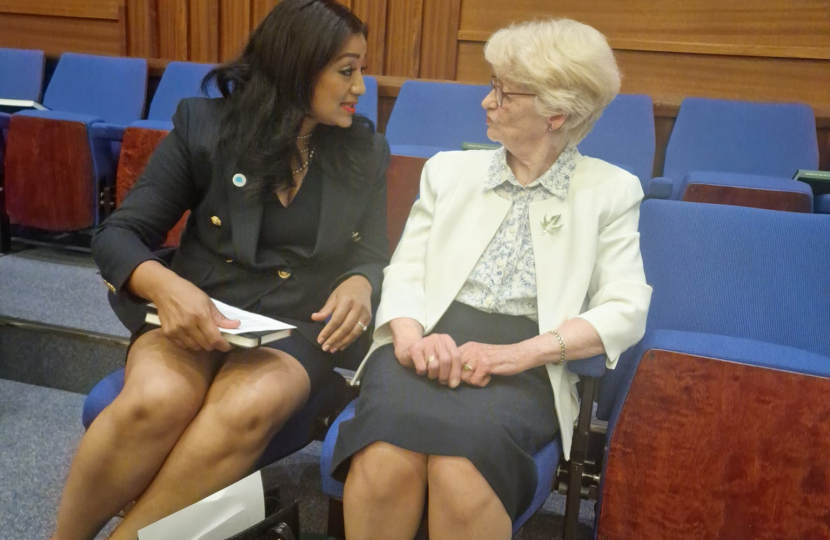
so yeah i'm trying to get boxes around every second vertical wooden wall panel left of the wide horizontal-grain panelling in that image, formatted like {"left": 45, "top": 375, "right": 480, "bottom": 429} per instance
{"left": 383, "top": 0, "right": 424, "bottom": 77}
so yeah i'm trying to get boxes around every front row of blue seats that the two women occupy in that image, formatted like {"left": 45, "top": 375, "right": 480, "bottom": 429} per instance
{"left": 83, "top": 200, "right": 830, "bottom": 540}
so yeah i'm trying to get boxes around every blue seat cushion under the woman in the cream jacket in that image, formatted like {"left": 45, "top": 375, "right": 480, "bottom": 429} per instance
{"left": 320, "top": 398, "right": 564, "bottom": 534}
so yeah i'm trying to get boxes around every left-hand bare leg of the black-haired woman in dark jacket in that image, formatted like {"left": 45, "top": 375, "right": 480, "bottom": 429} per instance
{"left": 53, "top": 330, "right": 218, "bottom": 540}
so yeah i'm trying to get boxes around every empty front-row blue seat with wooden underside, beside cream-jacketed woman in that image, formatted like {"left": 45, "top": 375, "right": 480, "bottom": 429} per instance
{"left": 595, "top": 200, "right": 830, "bottom": 538}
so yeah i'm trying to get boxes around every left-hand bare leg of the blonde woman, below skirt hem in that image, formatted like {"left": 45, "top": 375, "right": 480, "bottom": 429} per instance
{"left": 343, "top": 442, "right": 427, "bottom": 540}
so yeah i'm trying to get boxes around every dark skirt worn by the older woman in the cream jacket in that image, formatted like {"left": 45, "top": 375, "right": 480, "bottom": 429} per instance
{"left": 332, "top": 302, "right": 559, "bottom": 521}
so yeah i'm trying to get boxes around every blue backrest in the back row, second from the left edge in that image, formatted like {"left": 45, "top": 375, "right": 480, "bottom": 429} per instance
{"left": 43, "top": 53, "right": 147, "bottom": 125}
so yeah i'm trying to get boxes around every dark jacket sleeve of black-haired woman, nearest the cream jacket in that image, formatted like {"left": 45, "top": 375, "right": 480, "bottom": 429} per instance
{"left": 332, "top": 135, "right": 389, "bottom": 303}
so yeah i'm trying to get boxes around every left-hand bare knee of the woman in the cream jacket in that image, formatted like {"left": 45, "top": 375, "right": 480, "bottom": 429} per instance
{"left": 347, "top": 442, "right": 427, "bottom": 501}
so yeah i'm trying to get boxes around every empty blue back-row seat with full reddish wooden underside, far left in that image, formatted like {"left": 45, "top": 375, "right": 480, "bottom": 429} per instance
{"left": 6, "top": 53, "right": 147, "bottom": 231}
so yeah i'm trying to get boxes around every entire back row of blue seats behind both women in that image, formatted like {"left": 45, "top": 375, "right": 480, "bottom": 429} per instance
{"left": 0, "top": 49, "right": 830, "bottom": 245}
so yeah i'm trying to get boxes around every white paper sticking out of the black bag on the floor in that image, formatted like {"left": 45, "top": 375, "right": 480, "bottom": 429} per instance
{"left": 138, "top": 471, "right": 265, "bottom": 540}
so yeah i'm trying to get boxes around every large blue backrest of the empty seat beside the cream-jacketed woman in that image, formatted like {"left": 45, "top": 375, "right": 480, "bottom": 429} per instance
{"left": 597, "top": 200, "right": 830, "bottom": 418}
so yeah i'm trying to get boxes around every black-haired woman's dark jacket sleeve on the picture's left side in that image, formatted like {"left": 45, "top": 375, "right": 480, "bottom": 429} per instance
{"left": 92, "top": 100, "right": 198, "bottom": 293}
